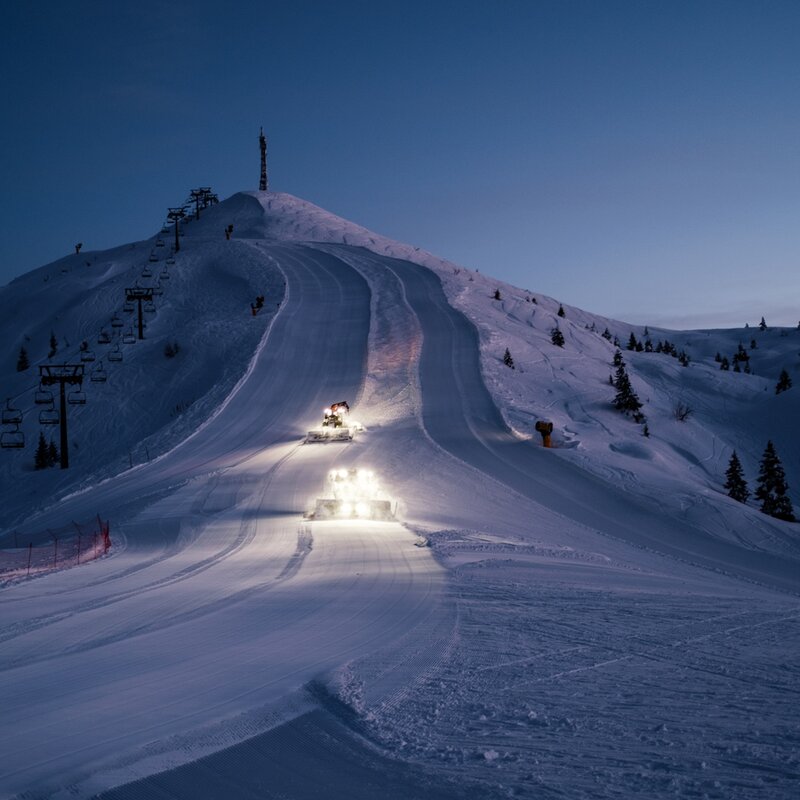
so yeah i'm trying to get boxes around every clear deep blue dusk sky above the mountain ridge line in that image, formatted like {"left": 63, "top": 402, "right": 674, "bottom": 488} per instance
{"left": 0, "top": 0, "right": 800, "bottom": 327}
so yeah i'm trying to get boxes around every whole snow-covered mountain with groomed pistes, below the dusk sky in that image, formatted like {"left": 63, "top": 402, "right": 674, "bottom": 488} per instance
{"left": 0, "top": 192, "right": 800, "bottom": 798}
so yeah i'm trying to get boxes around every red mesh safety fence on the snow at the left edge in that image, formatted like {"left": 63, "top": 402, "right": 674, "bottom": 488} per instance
{"left": 0, "top": 514, "right": 111, "bottom": 580}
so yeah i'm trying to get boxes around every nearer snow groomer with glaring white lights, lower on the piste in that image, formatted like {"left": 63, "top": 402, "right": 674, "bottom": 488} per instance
{"left": 306, "top": 469, "right": 397, "bottom": 521}
